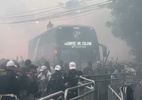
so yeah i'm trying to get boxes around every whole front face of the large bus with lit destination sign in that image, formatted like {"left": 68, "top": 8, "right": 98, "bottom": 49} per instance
{"left": 56, "top": 26, "right": 100, "bottom": 67}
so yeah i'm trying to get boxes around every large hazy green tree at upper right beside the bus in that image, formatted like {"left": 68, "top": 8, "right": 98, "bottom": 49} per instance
{"left": 107, "top": 0, "right": 142, "bottom": 62}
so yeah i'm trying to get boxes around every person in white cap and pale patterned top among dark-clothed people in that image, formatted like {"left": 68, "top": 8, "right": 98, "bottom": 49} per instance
{"left": 38, "top": 66, "right": 51, "bottom": 97}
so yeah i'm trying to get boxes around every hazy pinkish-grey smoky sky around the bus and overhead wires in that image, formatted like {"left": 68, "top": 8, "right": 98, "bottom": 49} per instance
{"left": 0, "top": 0, "right": 132, "bottom": 61}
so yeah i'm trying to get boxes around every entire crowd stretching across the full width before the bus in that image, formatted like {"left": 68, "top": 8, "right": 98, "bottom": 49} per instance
{"left": 0, "top": 59, "right": 142, "bottom": 100}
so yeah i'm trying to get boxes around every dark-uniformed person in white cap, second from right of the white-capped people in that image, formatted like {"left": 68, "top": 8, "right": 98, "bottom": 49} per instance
{"left": 47, "top": 65, "right": 64, "bottom": 100}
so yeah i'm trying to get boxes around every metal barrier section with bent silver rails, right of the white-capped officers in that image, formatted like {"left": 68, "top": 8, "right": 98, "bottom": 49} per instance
{"left": 64, "top": 76, "right": 95, "bottom": 100}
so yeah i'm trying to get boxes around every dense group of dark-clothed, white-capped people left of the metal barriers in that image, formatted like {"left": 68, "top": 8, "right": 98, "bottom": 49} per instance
{"left": 0, "top": 59, "right": 83, "bottom": 100}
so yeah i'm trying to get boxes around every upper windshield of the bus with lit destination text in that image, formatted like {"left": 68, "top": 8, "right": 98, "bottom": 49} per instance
{"left": 57, "top": 27, "right": 98, "bottom": 49}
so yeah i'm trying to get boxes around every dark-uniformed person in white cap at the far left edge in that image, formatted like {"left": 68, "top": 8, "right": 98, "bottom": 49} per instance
{"left": 0, "top": 60, "right": 20, "bottom": 100}
